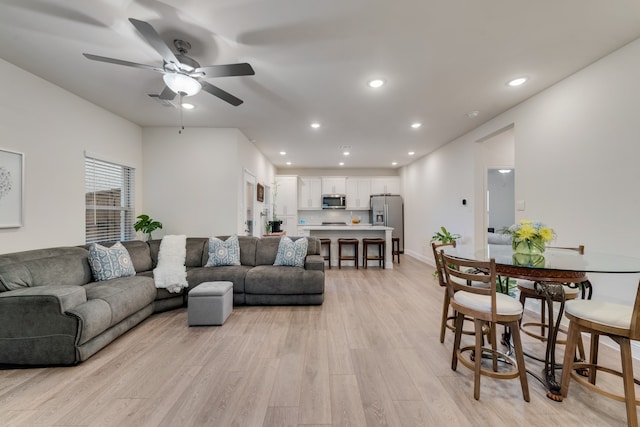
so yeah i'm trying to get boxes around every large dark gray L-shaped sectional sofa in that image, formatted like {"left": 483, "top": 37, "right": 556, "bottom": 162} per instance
{"left": 0, "top": 236, "right": 324, "bottom": 366}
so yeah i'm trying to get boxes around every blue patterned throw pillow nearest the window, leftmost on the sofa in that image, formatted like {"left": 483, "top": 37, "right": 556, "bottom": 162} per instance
{"left": 89, "top": 242, "right": 136, "bottom": 282}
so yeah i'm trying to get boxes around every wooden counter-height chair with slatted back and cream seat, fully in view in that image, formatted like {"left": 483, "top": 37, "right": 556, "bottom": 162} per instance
{"left": 440, "top": 250, "right": 529, "bottom": 402}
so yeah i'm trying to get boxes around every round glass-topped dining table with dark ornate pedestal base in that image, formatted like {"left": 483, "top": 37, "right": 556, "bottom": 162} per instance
{"left": 444, "top": 244, "right": 640, "bottom": 402}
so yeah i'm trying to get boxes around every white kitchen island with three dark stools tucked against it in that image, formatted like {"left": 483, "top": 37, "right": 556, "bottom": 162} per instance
{"left": 302, "top": 224, "right": 393, "bottom": 268}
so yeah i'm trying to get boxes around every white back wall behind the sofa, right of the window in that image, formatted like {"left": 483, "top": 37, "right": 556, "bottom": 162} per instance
{"left": 142, "top": 127, "right": 275, "bottom": 238}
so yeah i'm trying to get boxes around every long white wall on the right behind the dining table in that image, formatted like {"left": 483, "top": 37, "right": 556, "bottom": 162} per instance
{"left": 402, "top": 36, "right": 640, "bottom": 302}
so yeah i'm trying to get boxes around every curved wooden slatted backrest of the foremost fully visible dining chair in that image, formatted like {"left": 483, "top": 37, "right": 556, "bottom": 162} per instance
{"left": 440, "top": 251, "right": 497, "bottom": 321}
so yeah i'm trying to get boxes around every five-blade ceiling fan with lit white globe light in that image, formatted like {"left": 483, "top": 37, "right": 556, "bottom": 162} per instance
{"left": 83, "top": 18, "right": 255, "bottom": 106}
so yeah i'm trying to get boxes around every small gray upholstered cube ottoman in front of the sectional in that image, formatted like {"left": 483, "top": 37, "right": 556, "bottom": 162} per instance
{"left": 187, "top": 282, "right": 233, "bottom": 326}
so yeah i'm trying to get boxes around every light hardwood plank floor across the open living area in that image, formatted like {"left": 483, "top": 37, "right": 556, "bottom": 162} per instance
{"left": 0, "top": 256, "right": 626, "bottom": 426}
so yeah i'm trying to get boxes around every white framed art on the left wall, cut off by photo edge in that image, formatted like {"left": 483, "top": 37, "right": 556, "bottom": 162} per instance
{"left": 0, "top": 148, "right": 24, "bottom": 228}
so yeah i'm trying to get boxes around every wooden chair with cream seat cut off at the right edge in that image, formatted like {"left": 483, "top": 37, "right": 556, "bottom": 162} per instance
{"left": 560, "top": 283, "right": 640, "bottom": 426}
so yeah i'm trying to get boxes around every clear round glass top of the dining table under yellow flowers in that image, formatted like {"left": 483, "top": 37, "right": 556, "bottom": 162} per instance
{"left": 443, "top": 245, "right": 640, "bottom": 273}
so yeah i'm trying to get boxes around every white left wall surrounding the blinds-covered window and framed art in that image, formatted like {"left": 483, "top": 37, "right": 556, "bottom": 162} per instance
{"left": 0, "top": 59, "right": 143, "bottom": 253}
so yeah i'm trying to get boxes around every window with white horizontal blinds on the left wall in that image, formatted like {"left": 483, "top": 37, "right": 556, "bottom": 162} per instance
{"left": 85, "top": 156, "right": 135, "bottom": 243}
